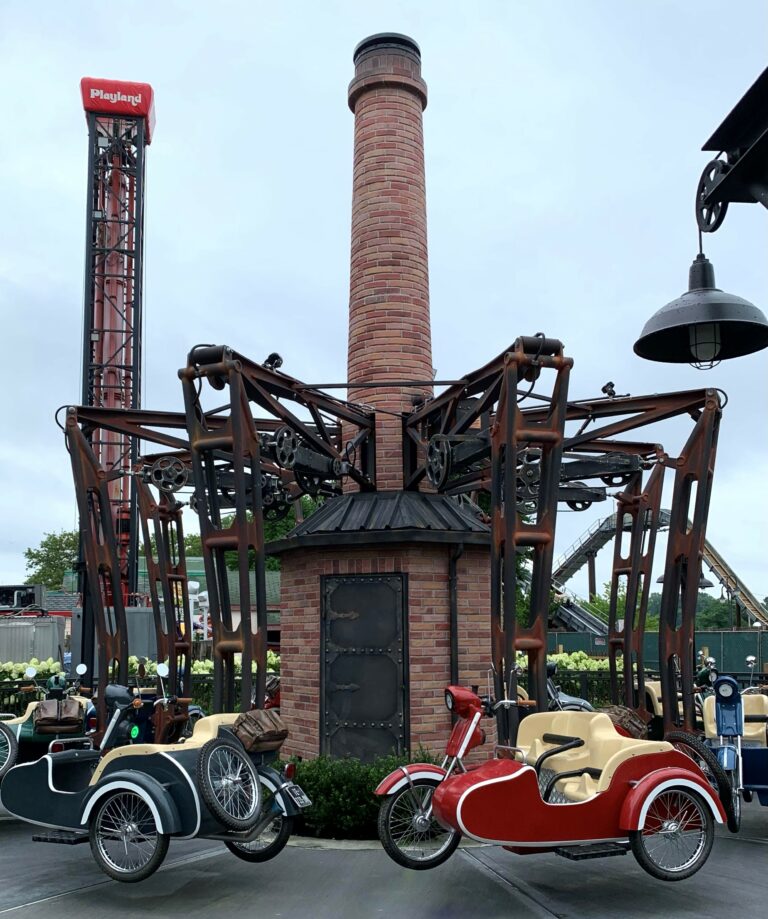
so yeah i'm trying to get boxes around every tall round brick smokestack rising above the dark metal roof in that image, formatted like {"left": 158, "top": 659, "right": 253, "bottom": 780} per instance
{"left": 347, "top": 34, "right": 433, "bottom": 491}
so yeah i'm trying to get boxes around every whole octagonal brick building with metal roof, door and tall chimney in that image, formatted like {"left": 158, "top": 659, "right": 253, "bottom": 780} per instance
{"left": 276, "top": 34, "right": 490, "bottom": 759}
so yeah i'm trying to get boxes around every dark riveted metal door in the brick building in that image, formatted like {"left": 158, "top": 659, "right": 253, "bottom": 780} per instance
{"left": 320, "top": 574, "right": 408, "bottom": 762}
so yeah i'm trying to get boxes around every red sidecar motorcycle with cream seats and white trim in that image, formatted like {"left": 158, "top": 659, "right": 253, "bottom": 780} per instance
{"left": 377, "top": 686, "right": 726, "bottom": 881}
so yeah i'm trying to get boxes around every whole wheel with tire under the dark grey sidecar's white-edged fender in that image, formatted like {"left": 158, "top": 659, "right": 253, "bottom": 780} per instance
{"left": 88, "top": 789, "right": 169, "bottom": 883}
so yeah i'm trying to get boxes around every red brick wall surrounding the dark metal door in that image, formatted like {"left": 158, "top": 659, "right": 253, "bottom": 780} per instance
{"left": 280, "top": 546, "right": 491, "bottom": 757}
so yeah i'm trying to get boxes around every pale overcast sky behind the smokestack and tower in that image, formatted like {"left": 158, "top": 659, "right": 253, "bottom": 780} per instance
{"left": 0, "top": 0, "right": 768, "bottom": 598}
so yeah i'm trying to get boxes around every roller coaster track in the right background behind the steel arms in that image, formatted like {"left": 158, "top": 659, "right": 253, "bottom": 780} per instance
{"left": 552, "top": 510, "right": 768, "bottom": 634}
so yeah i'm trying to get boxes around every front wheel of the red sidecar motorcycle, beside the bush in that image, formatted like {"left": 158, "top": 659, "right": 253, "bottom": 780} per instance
{"left": 378, "top": 779, "right": 461, "bottom": 871}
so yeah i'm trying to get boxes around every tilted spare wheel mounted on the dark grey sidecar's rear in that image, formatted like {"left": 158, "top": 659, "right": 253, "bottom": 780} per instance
{"left": 197, "top": 737, "right": 261, "bottom": 830}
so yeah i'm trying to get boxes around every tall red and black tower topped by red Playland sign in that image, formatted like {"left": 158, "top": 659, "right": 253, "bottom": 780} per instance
{"left": 80, "top": 77, "right": 154, "bottom": 601}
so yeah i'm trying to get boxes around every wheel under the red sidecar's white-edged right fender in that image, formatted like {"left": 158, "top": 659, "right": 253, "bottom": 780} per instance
{"left": 629, "top": 787, "right": 715, "bottom": 881}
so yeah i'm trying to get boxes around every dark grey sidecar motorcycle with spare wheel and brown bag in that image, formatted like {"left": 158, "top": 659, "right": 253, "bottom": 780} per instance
{"left": 0, "top": 668, "right": 311, "bottom": 882}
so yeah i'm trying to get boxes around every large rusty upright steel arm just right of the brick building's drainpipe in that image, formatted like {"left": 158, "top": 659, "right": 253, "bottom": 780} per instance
{"left": 491, "top": 338, "right": 573, "bottom": 743}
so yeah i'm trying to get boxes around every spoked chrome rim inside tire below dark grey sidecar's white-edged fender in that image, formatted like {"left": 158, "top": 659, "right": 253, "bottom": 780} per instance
{"left": 96, "top": 792, "right": 159, "bottom": 873}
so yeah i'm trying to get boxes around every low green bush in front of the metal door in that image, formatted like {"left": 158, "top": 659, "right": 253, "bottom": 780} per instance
{"left": 294, "top": 749, "right": 437, "bottom": 839}
